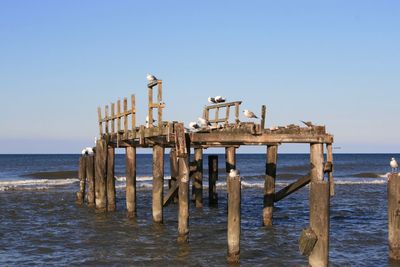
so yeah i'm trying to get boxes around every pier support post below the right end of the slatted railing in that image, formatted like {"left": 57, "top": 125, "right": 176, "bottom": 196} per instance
{"left": 125, "top": 146, "right": 136, "bottom": 218}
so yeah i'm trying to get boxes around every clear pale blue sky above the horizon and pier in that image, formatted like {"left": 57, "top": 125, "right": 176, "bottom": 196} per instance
{"left": 0, "top": 0, "right": 400, "bottom": 153}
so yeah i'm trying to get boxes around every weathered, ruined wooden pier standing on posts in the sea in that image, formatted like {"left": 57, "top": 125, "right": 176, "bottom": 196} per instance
{"left": 77, "top": 80, "right": 334, "bottom": 266}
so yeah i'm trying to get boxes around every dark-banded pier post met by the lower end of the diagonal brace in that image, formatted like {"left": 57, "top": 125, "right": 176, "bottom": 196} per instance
{"left": 263, "top": 145, "right": 278, "bottom": 227}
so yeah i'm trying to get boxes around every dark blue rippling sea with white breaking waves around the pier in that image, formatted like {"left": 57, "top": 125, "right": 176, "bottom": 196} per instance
{"left": 0, "top": 154, "right": 400, "bottom": 266}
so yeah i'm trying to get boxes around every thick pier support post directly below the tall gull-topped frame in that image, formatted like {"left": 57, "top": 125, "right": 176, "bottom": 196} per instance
{"left": 153, "top": 144, "right": 164, "bottom": 223}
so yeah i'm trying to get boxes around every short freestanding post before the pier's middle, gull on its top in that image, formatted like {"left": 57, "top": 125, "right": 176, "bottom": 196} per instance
{"left": 227, "top": 175, "right": 241, "bottom": 262}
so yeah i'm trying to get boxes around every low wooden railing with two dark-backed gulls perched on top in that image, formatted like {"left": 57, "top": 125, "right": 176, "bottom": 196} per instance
{"left": 204, "top": 101, "right": 242, "bottom": 126}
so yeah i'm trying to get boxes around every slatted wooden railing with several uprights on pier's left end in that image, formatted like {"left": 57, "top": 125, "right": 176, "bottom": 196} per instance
{"left": 97, "top": 95, "right": 136, "bottom": 136}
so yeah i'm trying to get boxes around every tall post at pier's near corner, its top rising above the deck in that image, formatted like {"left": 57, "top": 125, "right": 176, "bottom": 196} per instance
{"left": 175, "top": 123, "right": 189, "bottom": 243}
